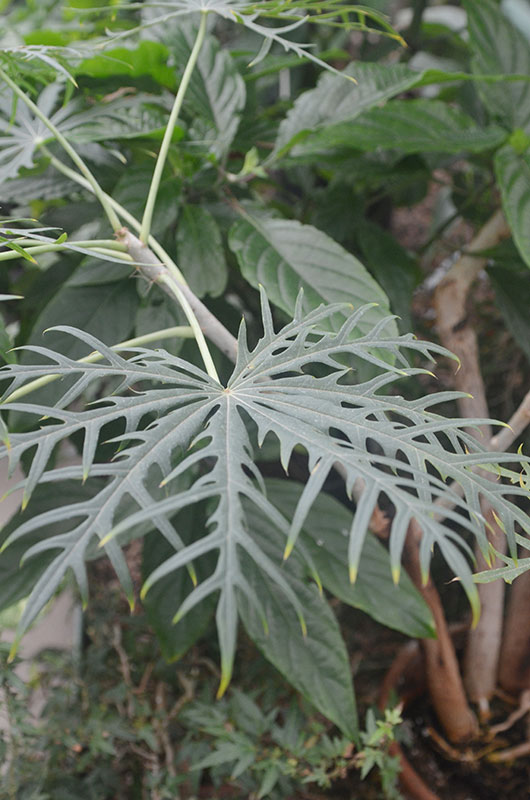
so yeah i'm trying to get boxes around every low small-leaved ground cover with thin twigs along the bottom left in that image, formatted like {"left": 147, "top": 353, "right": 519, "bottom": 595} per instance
{"left": 0, "top": 604, "right": 400, "bottom": 800}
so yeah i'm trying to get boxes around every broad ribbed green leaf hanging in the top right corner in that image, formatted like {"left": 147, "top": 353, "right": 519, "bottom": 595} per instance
{"left": 464, "top": 0, "right": 530, "bottom": 132}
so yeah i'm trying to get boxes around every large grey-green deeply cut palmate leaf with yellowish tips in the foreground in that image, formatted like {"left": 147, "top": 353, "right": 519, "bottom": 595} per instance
{"left": 0, "top": 292, "right": 530, "bottom": 693}
